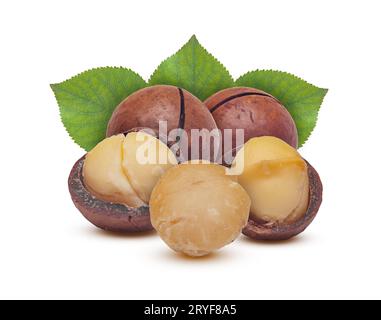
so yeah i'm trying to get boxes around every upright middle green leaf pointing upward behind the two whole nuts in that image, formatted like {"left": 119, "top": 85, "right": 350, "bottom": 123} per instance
{"left": 148, "top": 36, "right": 234, "bottom": 100}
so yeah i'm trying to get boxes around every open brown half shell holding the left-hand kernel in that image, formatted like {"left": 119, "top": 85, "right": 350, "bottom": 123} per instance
{"left": 68, "top": 156, "right": 153, "bottom": 232}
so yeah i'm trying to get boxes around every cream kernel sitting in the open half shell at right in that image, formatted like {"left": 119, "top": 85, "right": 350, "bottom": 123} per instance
{"left": 233, "top": 137, "right": 309, "bottom": 223}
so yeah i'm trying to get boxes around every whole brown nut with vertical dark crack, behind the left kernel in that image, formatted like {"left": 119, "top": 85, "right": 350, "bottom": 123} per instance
{"left": 106, "top": 85, "right": 217, "bottom": 160}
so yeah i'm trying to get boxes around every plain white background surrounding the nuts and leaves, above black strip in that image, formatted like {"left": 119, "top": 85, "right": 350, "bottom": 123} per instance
{"left": 0, "top": 0, "right": 381, "bottom": 299}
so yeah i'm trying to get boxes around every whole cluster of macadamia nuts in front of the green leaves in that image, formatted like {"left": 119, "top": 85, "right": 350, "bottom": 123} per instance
{"left": 69, "top": 85, "right": 322, "bottom": 256}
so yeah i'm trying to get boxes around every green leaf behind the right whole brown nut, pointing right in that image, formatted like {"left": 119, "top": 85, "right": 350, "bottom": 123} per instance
{"left": 236, "top": 70, "right": 328, "bottom": 147}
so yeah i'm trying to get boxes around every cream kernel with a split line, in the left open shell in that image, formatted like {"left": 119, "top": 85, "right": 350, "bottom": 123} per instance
{"left": 83, "top": 132, "right": 176, "bottom": 207}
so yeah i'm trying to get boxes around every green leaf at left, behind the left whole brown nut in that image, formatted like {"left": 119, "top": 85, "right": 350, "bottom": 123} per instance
{"left": 50, "top": 67, "right": 147, "bottom": 151}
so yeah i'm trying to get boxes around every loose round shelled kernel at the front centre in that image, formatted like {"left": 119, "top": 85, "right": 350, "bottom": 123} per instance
{"left": 150, "top": 163, "right": 250, "bottom": 256}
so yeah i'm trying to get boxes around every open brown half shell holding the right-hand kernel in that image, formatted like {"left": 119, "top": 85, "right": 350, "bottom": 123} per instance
{"left": 242, "top": 161, "right": 323, "bottom": 241}
